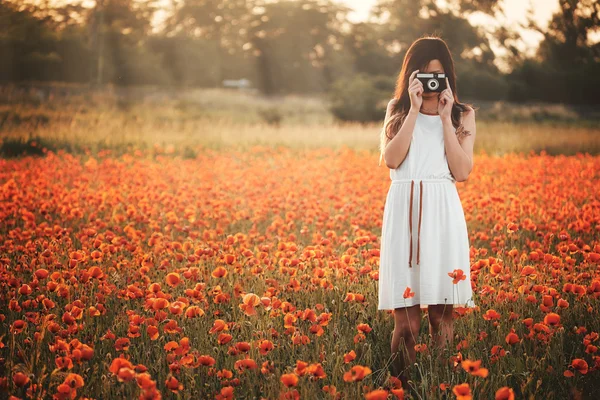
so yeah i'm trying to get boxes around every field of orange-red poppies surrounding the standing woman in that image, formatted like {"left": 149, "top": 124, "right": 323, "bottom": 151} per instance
{"left": 0, "top": 146, "right": 600, "bottom": 400}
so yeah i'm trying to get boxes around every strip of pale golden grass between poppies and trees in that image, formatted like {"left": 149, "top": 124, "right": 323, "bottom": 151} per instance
{"left": 0, "top": 88, "right": 600, "bottom": 157}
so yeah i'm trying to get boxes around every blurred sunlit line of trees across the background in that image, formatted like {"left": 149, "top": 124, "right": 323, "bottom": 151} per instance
{"left": 0, "top": 0, "right": 600, "bottom": 104}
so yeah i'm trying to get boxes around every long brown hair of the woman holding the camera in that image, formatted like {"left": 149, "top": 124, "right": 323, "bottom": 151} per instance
{"left": 379, "top": 35, "right": 474, "bottom": 166}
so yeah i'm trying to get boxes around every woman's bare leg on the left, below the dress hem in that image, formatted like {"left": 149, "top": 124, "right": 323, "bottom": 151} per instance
{"left": 391, "top": 304, "right": 421, "bottom": 388}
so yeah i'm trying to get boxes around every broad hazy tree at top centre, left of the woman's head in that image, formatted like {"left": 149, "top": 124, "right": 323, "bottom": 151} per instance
{"left": 248, "top": 0, "right": 352, "bottom": 94}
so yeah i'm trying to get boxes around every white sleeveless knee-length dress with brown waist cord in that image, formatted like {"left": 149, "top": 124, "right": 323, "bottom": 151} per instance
{"left": 378, "top": 113, "right": 475, "bottom": 310}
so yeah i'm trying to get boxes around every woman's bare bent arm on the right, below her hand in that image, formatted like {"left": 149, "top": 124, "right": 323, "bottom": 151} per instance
{"left": 442, "top": 107, "right": 476, "bottom": 182}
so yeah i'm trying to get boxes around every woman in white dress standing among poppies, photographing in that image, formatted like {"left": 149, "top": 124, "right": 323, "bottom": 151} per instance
{"left": 378, "top": 36, "right": 475, "bottom": 387}
